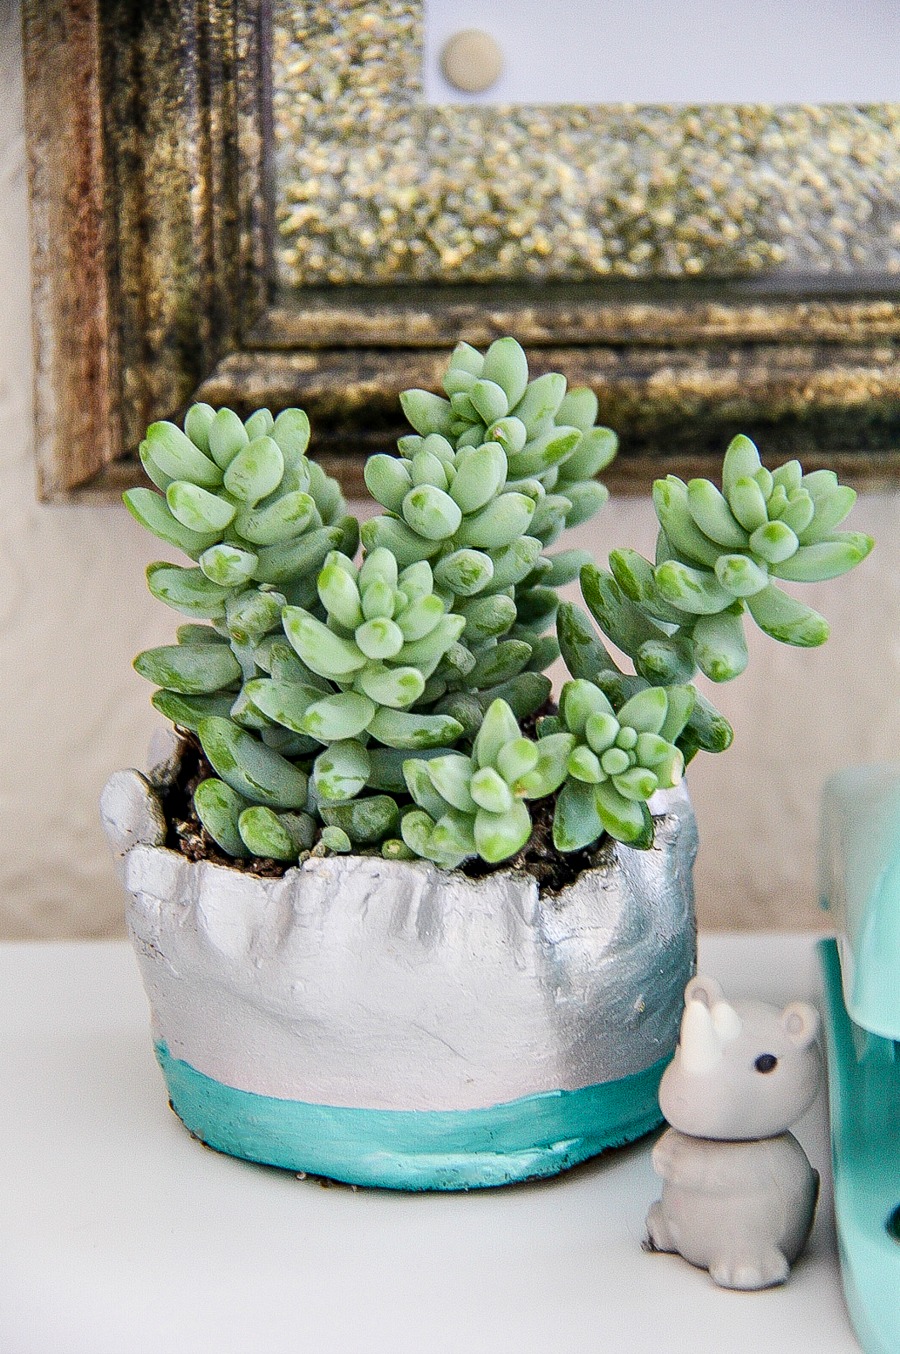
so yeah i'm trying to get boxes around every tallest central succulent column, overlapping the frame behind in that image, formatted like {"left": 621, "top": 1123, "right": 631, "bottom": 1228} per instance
{"left": 363, "top": 339, "right": 617, "bottom": 715}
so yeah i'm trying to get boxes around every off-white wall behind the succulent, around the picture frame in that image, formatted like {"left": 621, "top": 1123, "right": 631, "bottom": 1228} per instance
{"left": 0, "top": 0, "right": 900, "bottom": 938}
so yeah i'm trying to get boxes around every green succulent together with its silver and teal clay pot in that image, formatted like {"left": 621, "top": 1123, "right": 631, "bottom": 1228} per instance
{"left": 102, "top": 339, "right": 872, "bottom": 1189}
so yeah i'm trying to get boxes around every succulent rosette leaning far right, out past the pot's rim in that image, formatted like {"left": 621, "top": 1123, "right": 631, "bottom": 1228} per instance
{"left": 568, "top": 436, "right": 873, "bottom": 682}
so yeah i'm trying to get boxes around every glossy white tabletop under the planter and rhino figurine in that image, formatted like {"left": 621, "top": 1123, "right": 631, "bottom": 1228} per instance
{"left": 0, "top": 936, "right": 858, "bottom": 1354}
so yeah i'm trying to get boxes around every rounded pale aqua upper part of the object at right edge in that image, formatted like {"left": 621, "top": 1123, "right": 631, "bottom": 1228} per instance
{"left": 822, "top": 764, "right": 900, "bottom": 1034}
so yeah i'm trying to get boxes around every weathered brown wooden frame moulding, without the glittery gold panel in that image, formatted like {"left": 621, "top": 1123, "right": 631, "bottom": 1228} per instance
{"left": 17, "top": 0, "right": 900, "bottom": 501}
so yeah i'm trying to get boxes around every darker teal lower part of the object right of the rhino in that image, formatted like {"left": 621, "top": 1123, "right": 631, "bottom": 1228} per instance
{"left": 819, "top": 942, "right": 900, "bottom": 1354}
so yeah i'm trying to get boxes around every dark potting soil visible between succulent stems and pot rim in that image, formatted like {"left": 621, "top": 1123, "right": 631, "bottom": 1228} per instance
{"left": 158, "top": 708, "right": 612, "bottom": 898}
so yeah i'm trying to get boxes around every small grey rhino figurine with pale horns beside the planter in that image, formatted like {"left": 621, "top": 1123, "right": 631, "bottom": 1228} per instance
{"left": 647, "top": 976, "right": 822, "bottom": 1289}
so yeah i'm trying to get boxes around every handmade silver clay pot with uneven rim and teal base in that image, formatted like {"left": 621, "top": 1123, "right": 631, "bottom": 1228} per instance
{"left": 102, "top": 747, "right": 697, "bottom": 1189}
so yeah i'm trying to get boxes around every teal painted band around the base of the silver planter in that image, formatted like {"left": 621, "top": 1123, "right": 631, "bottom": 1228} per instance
{"left": 156, "top": 1044, "right": 669, "bottom": 1190}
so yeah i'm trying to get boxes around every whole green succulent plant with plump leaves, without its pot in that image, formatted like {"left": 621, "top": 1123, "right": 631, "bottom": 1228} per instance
{"left": 126, "top": 339, "right": 872, "bottom": 869}
